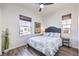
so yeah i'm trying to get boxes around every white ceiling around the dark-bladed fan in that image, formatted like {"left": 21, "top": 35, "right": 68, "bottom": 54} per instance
{"left": 22, "top": 3, "right": 75, "bottom": 16}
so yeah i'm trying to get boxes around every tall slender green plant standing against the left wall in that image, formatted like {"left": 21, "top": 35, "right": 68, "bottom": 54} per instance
{"left": 2, "top": 28, "right": 9, "bottom": 53}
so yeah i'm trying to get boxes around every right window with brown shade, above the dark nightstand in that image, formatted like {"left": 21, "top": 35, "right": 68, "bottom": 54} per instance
{"left": 62, "top": 14, "right": 72, "bottom": 37}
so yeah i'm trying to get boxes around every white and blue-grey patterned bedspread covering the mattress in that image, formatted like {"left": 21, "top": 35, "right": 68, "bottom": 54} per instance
{"left": 27, "top": 36, "right": 62, "bottom": 56}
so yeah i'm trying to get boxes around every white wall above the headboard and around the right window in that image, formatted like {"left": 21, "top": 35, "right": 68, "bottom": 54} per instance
{"left": 43, "top": 4, "right": 78, "bottom": 48}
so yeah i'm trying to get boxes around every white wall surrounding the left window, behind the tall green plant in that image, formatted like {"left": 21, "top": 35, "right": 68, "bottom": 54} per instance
{"left": 2, "top": 4, "right": 42, "bottom": 49}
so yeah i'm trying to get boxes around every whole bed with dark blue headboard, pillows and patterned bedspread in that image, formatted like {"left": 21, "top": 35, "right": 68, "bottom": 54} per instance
{"left": 27, "top": 26, "right": 62, "bottom": 56}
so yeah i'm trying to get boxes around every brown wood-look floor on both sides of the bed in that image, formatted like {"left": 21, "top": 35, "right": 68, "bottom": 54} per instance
{"left": 2, "top": 46, "right": 79, "bottom": 56}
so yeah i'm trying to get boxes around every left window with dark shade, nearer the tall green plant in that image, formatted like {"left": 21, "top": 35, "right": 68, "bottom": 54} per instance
{"left": 19, "top": 15, "right": 31, "bottom": 36}
